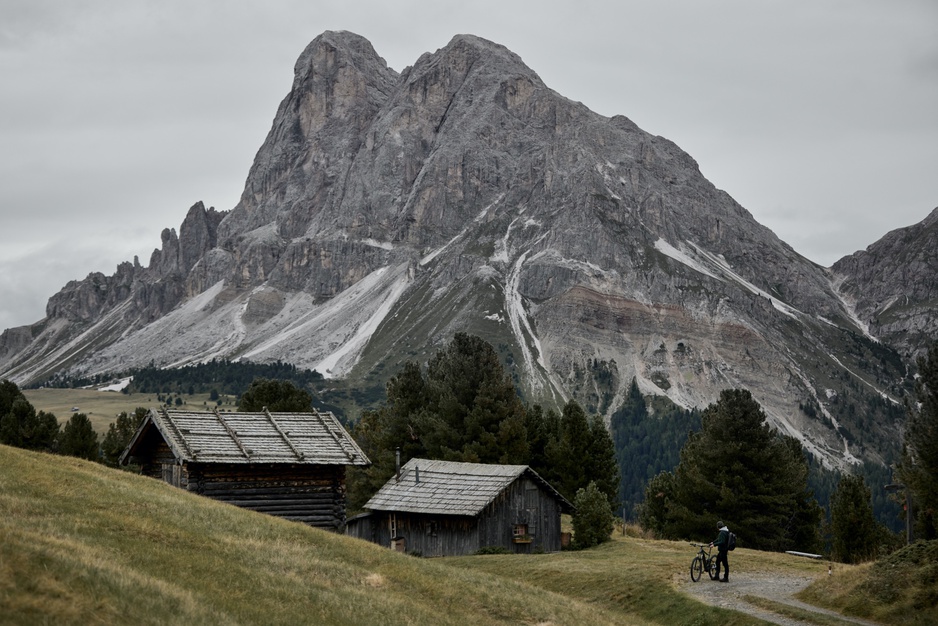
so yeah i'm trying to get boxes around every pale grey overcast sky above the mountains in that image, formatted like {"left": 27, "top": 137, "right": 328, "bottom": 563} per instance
{"left": 0, "top": 0, "right": 938, "bottom": 330}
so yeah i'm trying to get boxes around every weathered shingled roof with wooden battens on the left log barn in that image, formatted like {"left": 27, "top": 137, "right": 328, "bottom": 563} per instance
{"left": 121, "top": 409, "right": 370, "bottom": 465}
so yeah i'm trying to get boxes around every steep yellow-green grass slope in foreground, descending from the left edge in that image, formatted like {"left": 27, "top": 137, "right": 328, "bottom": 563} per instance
{"left": 0, "top": 446, "right": 622, "bottom": 626}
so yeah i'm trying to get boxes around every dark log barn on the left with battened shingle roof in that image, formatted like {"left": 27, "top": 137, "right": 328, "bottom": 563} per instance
{"left": 121, "top": 409, "right": 369, "bottom": 530}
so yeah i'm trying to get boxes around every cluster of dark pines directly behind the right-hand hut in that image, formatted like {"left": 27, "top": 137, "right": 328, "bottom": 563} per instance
{"left": 348, "top": 333, "right": 619, "bottom": 511}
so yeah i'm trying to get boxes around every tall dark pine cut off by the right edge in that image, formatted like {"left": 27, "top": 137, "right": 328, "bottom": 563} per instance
{"left": 898, "top": 341, "right": 938, "bottom": 539}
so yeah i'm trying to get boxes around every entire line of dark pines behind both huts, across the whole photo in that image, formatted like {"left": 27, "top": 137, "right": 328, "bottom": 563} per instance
{"left": 7, "top": 333, "right": 938, "bottom": 561}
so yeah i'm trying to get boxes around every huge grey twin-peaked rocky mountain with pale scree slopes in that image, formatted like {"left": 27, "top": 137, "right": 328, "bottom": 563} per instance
{"left": 0, "top": 32, "right": 920, "bottom": 466}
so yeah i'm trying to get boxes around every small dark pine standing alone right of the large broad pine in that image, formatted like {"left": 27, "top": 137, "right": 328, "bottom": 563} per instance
{"left": 831, "top": 474, "right": 880, "bottom": 563}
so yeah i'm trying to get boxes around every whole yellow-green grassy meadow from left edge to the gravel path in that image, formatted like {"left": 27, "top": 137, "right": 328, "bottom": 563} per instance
{"left": 0, "top": 446, "right": 924, "bottom": 626}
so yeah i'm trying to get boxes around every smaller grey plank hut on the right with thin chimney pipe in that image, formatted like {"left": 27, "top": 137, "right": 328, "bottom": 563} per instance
{"left": 346, "top": 459, "right": 573, "bottom": 556}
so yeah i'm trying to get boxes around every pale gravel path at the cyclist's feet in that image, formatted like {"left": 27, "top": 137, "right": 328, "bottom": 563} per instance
{"left": 676, "top": 572, "right": 878, "bottom": 626}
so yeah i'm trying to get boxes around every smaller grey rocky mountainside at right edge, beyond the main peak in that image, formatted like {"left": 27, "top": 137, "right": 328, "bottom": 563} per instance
{"left": 833, "top": 208, "right": 938, "bottom": 358}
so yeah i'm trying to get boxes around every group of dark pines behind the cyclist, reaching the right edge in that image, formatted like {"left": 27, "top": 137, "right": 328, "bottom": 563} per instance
{"left": 639, "top": 343, "right": 938, "bottom": 562}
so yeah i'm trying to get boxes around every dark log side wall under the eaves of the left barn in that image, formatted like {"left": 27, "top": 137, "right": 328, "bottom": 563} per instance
{"left": 187, "top": 462, "right": 346, "bottom": 530}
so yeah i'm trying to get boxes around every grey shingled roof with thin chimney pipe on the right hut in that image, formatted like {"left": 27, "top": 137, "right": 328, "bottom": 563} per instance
{"left": 364, "top": 459, "right": 573, "bottom": 516}
